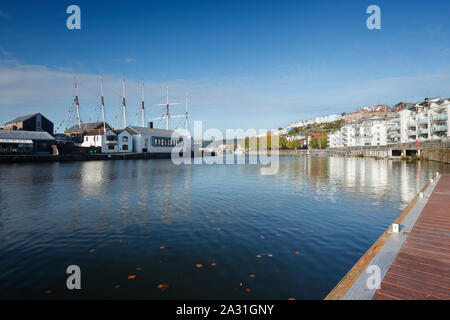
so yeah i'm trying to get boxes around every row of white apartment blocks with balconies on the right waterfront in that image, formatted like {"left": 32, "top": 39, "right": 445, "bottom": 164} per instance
{"left": 328, "top": 98, "right": 450, "bottom": 148}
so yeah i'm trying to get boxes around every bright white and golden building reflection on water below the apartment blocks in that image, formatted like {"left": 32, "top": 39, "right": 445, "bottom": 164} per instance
{"left": 268, "top": 156, "right": 436, "bottom": 203}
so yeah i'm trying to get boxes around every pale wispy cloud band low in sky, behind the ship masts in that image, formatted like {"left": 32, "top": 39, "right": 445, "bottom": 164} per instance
{"left": 0, "top": 56, "right": 450, "bottom": 129}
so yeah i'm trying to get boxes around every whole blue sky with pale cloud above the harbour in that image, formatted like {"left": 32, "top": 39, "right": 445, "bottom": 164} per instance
{"left": 0, "top": 0, "right": 450, "bottom": 129}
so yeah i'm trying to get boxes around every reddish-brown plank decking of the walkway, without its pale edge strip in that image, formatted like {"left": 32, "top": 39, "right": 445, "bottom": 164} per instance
{"left": 373, "top": 175, "right": 450, "bottom": 300}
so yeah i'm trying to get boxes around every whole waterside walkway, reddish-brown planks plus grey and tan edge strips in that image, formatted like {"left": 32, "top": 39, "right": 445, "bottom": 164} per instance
{"left": 325, "top": 175, "right": 450, "bottom": 300}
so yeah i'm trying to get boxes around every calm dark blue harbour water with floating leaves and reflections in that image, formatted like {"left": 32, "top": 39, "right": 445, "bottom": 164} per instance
{"left": 0, "top": 156, "right": 450, "bottom": 299}
